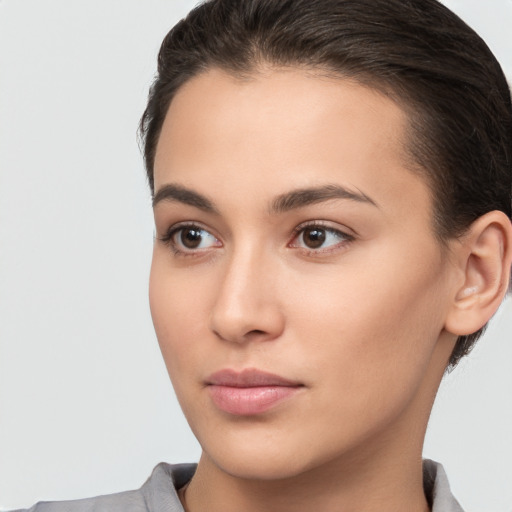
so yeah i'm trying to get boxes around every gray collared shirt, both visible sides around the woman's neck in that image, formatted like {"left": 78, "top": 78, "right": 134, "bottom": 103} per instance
{"left": 12, "top": 460, "right": 463, "bottom": 512}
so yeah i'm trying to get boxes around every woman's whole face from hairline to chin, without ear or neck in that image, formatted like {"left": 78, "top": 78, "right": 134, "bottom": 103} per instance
{"left": 150, "top": 69, "right": 458, "bottom": 479}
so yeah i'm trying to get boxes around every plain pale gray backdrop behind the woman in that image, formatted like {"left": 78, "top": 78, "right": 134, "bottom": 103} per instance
{"left": 0, "top": 0, "right": 512, "bottom": 512}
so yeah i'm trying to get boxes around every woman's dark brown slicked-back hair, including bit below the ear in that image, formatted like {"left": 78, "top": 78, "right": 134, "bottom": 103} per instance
{"left": 140, "top": 0, "right": 512, "bottom": 367}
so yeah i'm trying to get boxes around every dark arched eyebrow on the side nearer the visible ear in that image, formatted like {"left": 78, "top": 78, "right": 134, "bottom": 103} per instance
{"left": 270, "top": 185, "right": 378, "bottom": 214}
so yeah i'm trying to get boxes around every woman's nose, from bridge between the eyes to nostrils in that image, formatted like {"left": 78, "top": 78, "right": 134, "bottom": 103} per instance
{"left": 210, "top": 248, "right": 285, "bottom": 343}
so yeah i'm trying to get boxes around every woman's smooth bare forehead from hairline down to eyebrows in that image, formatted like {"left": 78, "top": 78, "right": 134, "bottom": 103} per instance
{"left": 155, "top": 69, "right": 430, "bottom": 222}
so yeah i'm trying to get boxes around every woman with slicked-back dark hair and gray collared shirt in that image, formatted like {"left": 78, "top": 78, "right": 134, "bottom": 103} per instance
{"left": 5, "top": 0, "right": 512, "bottom": 512}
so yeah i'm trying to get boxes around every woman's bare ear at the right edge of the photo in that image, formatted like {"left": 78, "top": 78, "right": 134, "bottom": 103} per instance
{"left": 445, "top": 211, "right": 512, "bottom": 336}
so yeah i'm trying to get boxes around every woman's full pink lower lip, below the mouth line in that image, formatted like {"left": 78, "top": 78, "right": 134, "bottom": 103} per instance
{"left": 208, "top": 385, "right": 300, "bottom": 416}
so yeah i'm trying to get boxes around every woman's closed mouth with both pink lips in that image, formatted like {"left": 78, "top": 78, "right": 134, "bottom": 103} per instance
{"left": 206, "top": 368, "right": 304, "bottom": 416}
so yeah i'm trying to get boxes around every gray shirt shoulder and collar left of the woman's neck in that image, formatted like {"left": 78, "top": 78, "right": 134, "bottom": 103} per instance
{"left": 12, "top": 462, "right": 196, "bottom": 512}
